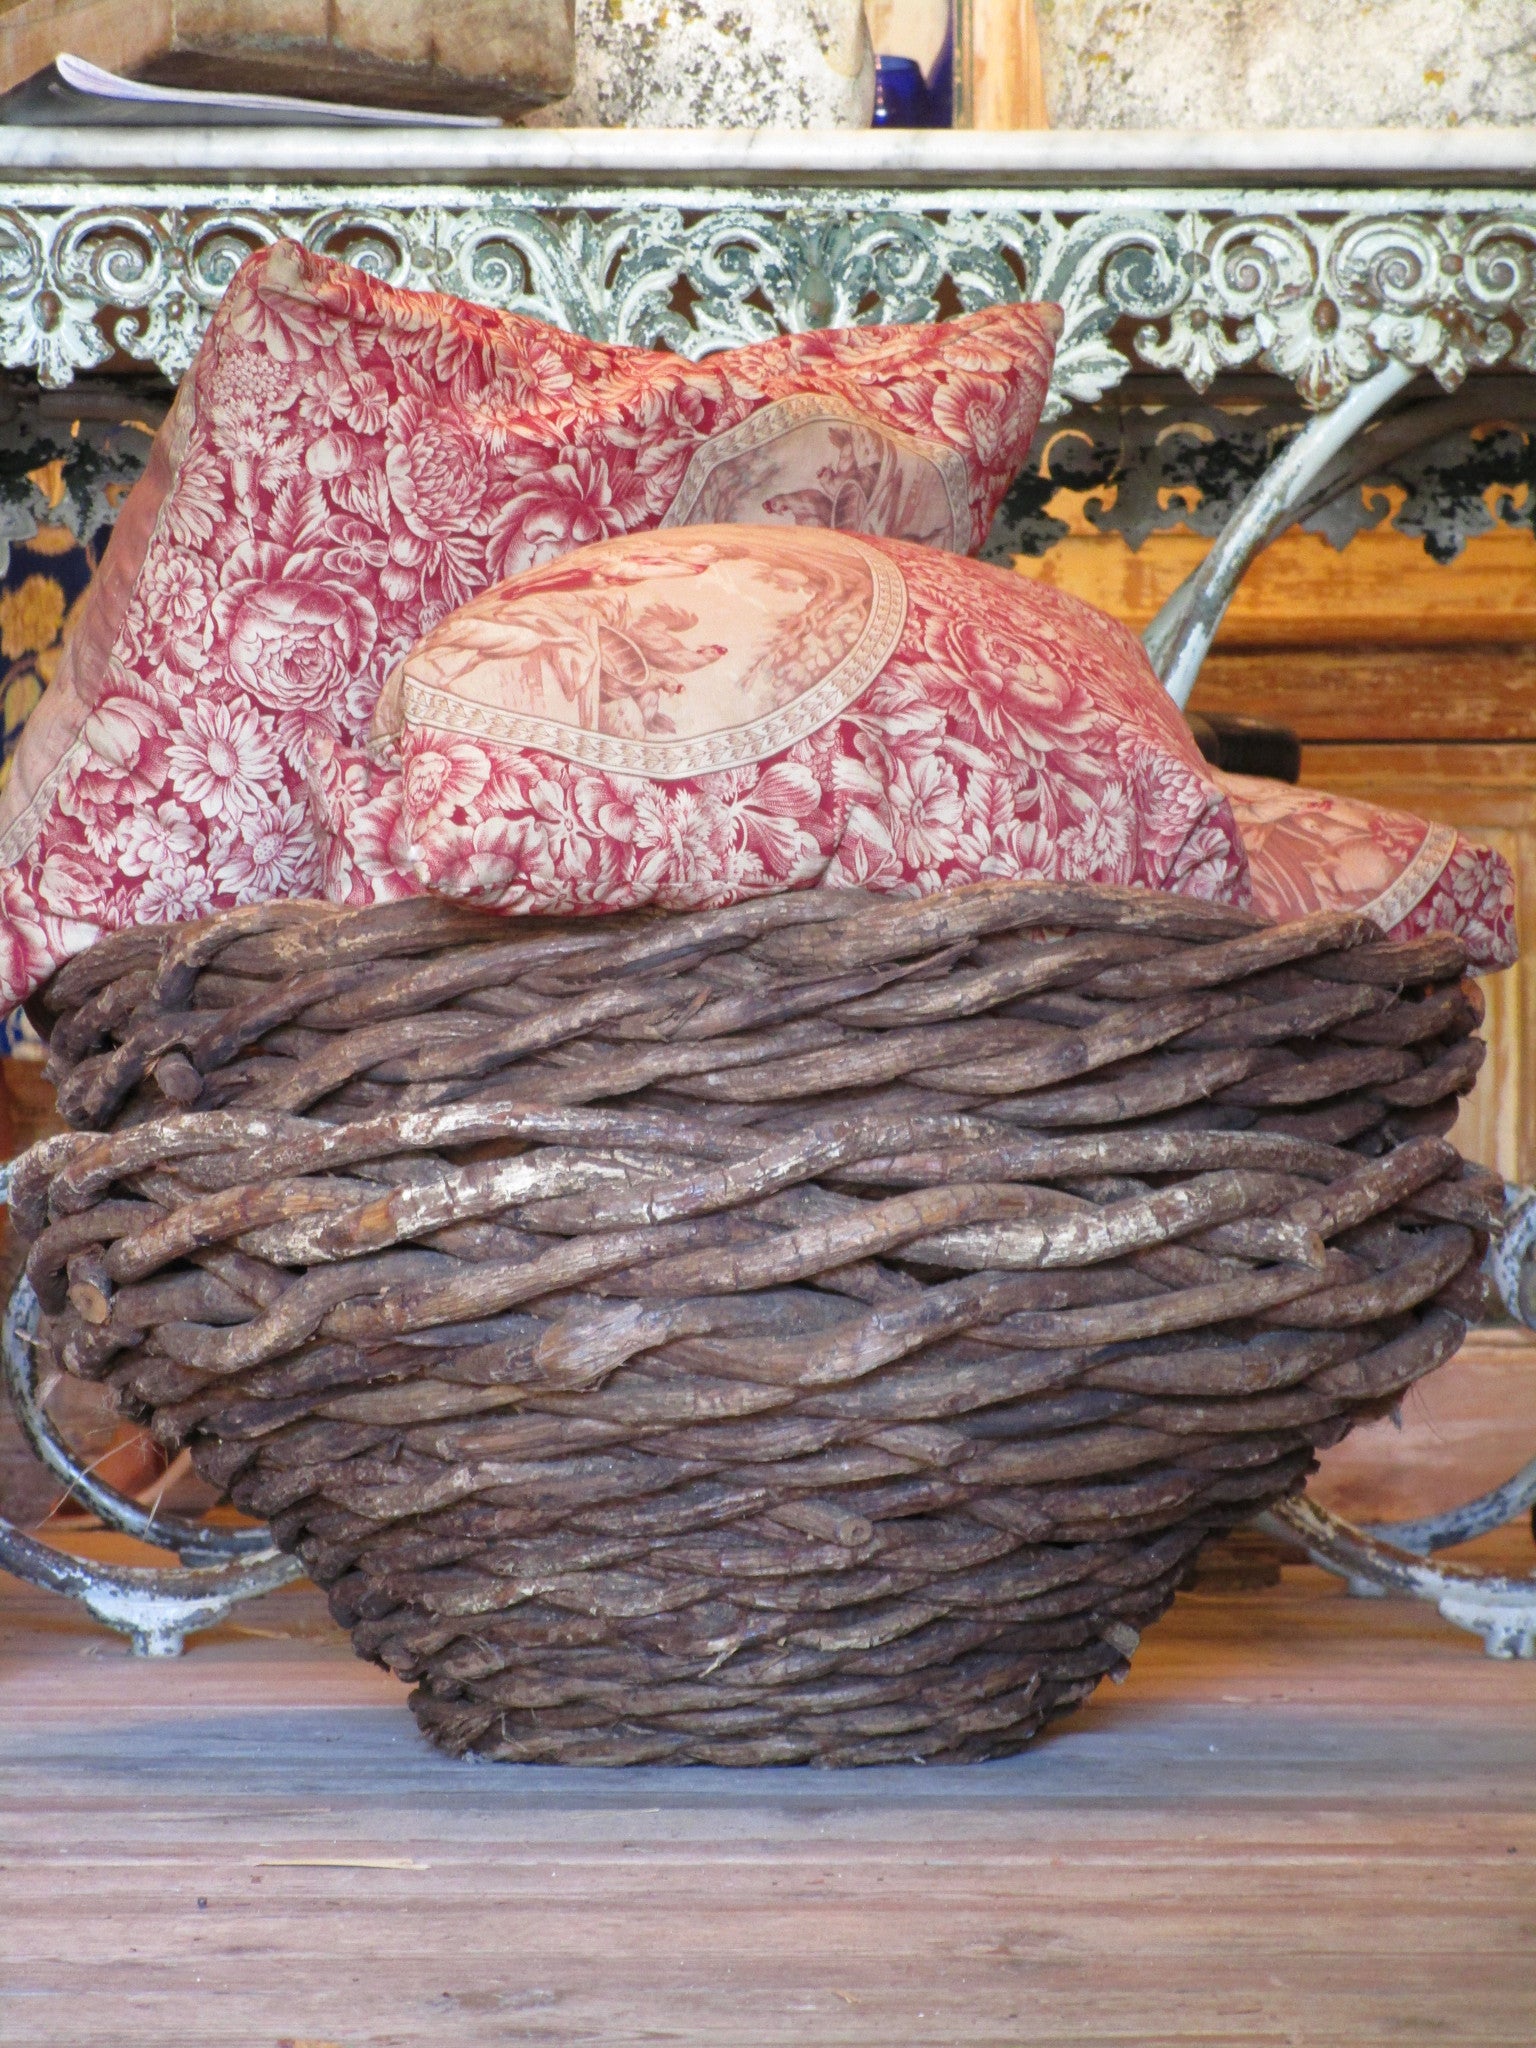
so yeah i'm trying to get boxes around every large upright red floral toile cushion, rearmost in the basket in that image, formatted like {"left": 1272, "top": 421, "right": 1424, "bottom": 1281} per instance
{"left": 0, "top": 242, "right": 1061, "bottom": 1001}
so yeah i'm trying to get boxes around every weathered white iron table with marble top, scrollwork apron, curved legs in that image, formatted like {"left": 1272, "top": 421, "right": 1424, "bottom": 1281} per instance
{"left": 0, "top": 129, "right": 1536, "bottom": 1657}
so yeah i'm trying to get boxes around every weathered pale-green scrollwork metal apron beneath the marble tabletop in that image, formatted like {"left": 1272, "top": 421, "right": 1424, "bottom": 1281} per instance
{"left": 0, "top": 178, "right": 1536, "bottom": 414}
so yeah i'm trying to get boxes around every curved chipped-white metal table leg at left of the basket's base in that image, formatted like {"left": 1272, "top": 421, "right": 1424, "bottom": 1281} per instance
{"left": 0, "top": 1236, "right": 303, "bottom": 1657}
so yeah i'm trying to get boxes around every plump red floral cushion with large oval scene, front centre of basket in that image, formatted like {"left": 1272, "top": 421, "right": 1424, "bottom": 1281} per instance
{"left": 327, "top": 526, "right": 1247, "bottom": 911}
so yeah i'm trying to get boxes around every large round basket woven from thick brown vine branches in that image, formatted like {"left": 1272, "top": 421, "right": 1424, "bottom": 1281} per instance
{"left": 12, "top": 883, "right": 1499, "bottom": 1763}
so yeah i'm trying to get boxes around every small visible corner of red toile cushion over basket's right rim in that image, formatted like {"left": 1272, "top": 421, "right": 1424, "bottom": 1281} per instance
{"left": 1217, "top": 774, "right": 1518, "bottom": 973}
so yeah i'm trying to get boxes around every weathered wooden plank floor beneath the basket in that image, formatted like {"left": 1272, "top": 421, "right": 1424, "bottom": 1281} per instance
{"left": 0, "top": 1532, "right": 1536, "bottom": 2048}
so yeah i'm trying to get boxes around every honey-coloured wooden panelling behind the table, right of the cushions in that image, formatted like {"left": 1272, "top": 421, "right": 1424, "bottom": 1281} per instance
{"left": 1018, "top": 520, "right": 1536, "bottom": 1180}
